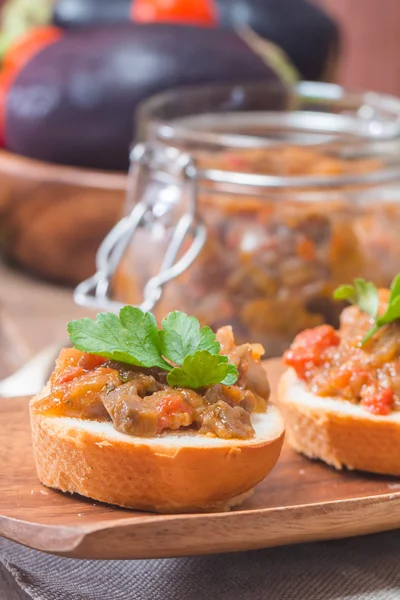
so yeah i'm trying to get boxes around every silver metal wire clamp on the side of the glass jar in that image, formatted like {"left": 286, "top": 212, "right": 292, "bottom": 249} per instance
{"left": 74, "top": 144, "right": 207, "bottom": 312}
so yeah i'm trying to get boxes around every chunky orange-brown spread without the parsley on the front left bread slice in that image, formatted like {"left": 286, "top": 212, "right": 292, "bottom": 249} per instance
{"left": 35, "top": 327, "right": 270, "bottom": 439}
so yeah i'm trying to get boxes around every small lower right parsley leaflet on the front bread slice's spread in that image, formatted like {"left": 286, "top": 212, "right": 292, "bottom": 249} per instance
{"left": 167, "top": 350, "right": 239, "bottom": 389}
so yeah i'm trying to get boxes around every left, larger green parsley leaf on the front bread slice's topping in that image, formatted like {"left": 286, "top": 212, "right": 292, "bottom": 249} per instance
{"left": 68, "top": 306, "right": 172, "bottom": 371}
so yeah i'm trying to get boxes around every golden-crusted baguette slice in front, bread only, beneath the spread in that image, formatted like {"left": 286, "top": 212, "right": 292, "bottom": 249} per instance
{"left": 31, "top": 396, "right": 284, "bottom": 513}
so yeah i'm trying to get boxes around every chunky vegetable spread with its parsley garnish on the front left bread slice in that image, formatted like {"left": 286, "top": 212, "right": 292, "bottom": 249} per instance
{"left": 35, "top": 306, "right": 270, "bottom": 439}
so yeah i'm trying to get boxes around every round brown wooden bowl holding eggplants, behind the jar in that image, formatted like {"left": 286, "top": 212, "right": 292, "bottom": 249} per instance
{"left": 0, "top": 150, "right": 126, "bottom": 285}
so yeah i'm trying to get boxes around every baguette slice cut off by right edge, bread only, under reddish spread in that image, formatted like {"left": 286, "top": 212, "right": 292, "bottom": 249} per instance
{"left": 278, "top": 369, "right": 400, "bottom": 476}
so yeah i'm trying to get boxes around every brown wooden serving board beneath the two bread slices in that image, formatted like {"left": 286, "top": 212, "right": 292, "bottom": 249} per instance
{"left": 0, "top": 361, "right": 400, "bottom": 559}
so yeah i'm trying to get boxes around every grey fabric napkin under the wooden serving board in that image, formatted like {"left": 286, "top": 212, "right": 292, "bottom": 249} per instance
{"left": 0, "top": 532, "right": 400, "bottom": 600}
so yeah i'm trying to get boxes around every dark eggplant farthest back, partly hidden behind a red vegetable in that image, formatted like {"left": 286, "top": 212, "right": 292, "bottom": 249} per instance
{"left": 54, "top": 0, "right": 340, "bottom": 80}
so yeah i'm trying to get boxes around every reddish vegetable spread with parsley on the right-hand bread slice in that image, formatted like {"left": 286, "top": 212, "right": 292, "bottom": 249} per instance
{"left": 284, "top": 275, "right": 400, "bottom": 415}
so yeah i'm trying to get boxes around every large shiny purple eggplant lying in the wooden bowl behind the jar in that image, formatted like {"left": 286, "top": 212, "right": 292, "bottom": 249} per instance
{"left": 5, "top": 23, "right": 284, "bottom": 170}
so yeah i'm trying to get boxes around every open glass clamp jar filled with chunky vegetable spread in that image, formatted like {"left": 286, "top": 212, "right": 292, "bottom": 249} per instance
{"left": 75, "top": 82, "right": 400, "bottom": 356}
